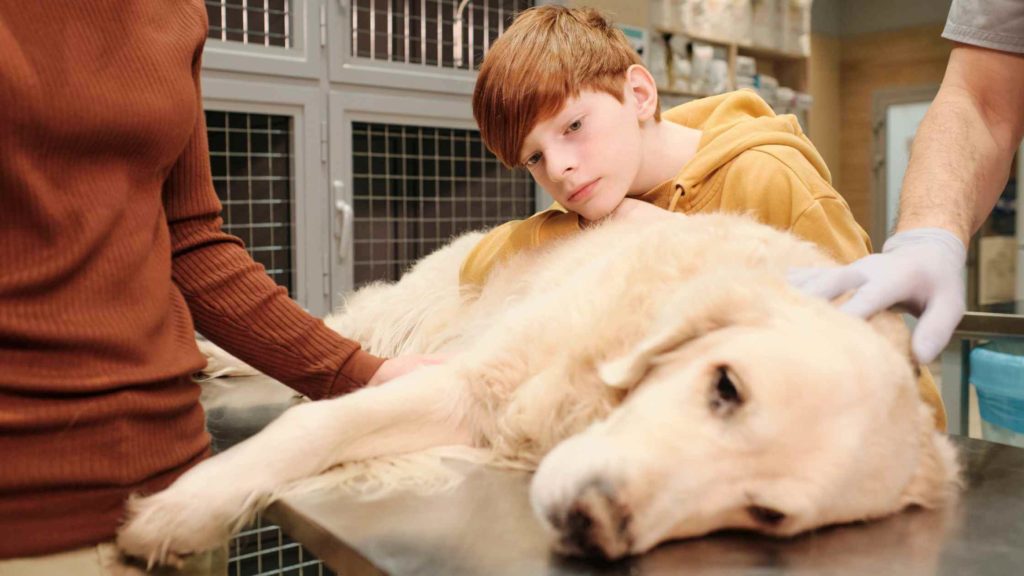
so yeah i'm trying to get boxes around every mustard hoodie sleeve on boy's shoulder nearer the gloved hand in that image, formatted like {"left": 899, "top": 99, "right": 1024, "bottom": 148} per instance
{"left": 720, "top": 146, "right": 871, "bottom": 263}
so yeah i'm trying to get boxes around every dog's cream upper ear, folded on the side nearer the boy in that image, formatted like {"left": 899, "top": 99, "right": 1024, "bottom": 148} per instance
{"left": 598, "top": 275, "right": 767, "bottom": 389}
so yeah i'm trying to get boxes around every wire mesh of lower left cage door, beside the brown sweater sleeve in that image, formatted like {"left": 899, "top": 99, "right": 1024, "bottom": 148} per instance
{"left": 206, "top": 111, "right": 295, "bottom": 298}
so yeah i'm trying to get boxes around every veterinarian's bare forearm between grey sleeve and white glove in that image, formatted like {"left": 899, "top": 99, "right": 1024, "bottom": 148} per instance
{"left": 896, "top": 48, "right": 1024, "bottom": 245}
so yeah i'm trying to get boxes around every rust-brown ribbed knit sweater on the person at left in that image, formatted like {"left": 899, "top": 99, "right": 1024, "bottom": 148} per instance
{"left": 0, "top": 0, "right": 381, "bottom": 558}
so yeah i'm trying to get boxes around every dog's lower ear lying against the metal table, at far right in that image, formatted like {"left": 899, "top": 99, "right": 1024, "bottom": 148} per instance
{"left": 900, "top": 403, "right": 963, "bottom": 508}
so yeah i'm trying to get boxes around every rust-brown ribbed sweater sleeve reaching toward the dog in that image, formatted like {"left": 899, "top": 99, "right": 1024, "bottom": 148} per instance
{"left": 163, "top": 54, "right": 383, "bottom": 399}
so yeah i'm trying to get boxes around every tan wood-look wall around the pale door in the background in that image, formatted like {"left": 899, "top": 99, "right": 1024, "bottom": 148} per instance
{"left": 808, "top": 0, "right": 951, "bottom": 231}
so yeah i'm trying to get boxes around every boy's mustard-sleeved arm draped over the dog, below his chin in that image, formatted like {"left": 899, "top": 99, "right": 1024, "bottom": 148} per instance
{"left": 459, "top": 205, "right": 581, "bottom": 287}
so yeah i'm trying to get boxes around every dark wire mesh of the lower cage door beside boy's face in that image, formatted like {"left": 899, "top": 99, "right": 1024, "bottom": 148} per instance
{"left": 352, "top": 122, "right": 536, "bottom": 287}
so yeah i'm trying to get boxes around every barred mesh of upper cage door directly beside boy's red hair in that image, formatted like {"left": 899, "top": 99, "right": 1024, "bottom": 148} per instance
{"left": 350, "top": 0, "right": 534, "bottom": 70}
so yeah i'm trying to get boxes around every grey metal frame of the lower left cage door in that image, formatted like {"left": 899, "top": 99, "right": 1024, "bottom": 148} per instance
{"left": 203, "top": 74, "right": 330, "bottom": 316}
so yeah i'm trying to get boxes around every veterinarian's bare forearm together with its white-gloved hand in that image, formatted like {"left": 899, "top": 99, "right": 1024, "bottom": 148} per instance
{"left": 792, "top": 45, "right": 1024, "bottom": 363}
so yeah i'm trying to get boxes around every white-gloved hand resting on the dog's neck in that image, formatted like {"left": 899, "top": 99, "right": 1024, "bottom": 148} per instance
{"left": 788, "top": 228, "right": 967, "bottom": 364}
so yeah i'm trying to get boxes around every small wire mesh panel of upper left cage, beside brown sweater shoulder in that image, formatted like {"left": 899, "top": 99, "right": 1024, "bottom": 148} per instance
{"left": 206, "top": 0, "right": 292, "bottom": 48}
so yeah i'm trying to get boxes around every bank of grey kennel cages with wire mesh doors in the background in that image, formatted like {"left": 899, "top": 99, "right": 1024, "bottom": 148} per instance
{"left": 203, "top": 0, "right": 537, "bottom": 576}
